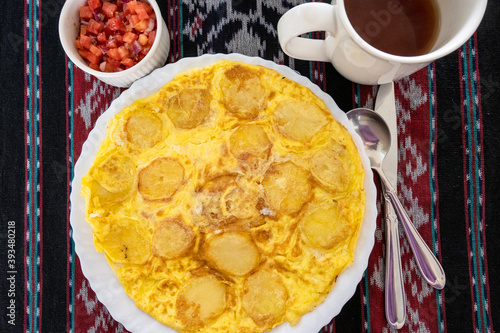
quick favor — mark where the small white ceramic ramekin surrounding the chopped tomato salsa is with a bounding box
[59,0,170,87]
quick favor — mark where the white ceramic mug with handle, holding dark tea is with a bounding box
[278,0,487,85]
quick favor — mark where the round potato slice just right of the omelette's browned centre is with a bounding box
[262,161,312,214]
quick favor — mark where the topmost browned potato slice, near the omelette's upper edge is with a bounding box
[220,65,267,119]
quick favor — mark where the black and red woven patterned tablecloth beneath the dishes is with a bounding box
[0,0,500,332]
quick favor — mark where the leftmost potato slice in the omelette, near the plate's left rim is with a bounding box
[92,153,136,193]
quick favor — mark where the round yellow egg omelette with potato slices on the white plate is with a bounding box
[82,60,365,333]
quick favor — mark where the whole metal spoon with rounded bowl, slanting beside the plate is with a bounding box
[347,109,446,289]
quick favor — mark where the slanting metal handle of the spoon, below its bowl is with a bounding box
[380,173,446,289]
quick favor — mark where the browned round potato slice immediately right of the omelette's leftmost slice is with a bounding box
[139,157,184,200]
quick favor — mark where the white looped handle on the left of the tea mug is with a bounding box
[278,2,337,61]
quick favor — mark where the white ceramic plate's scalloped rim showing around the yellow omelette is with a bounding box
[70,54,377,333]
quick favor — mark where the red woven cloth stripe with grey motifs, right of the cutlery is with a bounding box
[398,68,439,332]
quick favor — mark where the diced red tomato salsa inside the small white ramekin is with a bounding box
[75,0,157,72]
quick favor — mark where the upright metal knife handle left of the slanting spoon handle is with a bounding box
[384,190,406,329]
